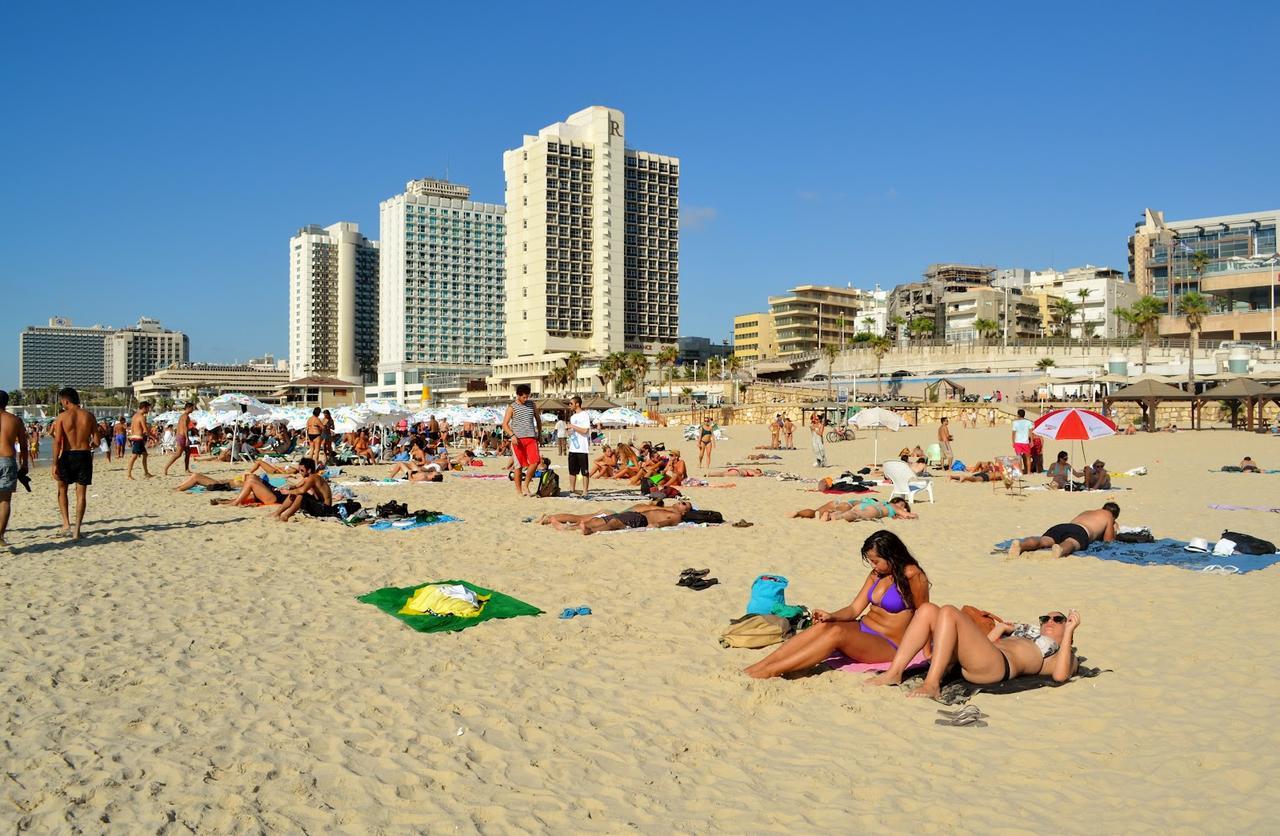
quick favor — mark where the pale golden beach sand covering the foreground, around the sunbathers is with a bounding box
[0,428,1280,833]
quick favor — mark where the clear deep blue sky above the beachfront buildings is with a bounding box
[0,3,1280,388]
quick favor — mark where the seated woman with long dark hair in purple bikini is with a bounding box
[746,529,929,679]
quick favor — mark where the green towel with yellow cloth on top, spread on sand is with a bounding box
[356,580,543,632]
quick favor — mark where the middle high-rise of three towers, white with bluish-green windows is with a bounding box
[366,179,507,403]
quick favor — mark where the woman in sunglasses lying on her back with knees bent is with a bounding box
[868,604,1080,696]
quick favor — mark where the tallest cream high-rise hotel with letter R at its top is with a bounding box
[490,106,680,390]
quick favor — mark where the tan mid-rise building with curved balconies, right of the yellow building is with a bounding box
[769,284,870,357]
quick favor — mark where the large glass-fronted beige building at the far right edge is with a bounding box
[1129,209,1280,341]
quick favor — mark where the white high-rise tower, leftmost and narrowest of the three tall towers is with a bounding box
[289,221,378,383]
